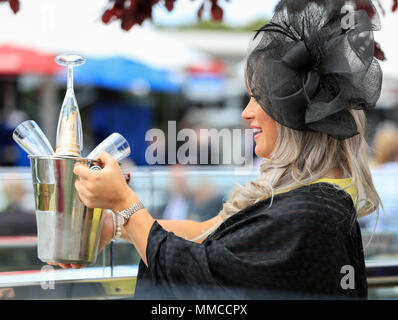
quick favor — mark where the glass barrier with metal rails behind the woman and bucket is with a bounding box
[0,167,398,299]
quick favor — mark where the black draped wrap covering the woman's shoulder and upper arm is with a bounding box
[135,182,367,299]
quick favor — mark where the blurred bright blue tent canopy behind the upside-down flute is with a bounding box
[65,57,180,93]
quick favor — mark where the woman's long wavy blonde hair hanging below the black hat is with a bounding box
[196,110,381,239]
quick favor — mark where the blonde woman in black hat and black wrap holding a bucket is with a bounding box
[53,0,381,299]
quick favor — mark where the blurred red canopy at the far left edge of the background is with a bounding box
[0,45,61,75]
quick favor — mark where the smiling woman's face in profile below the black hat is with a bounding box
[242,97,278,158]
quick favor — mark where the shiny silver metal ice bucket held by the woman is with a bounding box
[29,156,105,265]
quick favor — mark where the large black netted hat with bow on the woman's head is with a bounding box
[246,0,382,139]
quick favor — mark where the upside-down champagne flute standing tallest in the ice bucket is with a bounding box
[55,54,86,157]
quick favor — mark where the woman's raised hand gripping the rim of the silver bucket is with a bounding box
[73,152,137,212]
